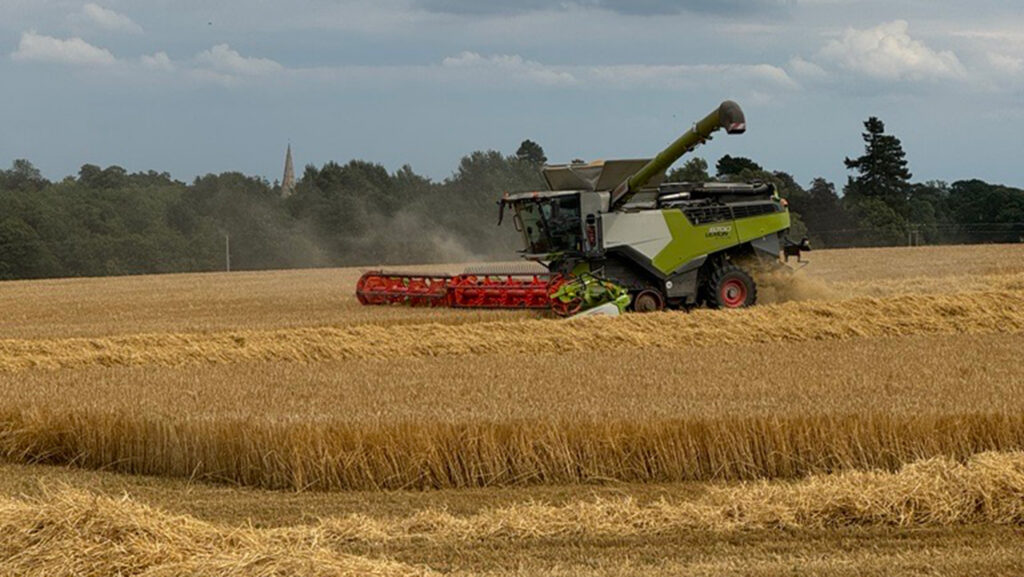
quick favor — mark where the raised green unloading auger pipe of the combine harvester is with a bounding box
[610,100,746,210]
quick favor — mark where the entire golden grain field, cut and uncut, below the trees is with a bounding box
[0,245,1024,576]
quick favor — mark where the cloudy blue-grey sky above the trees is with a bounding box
[0,0,1024,188]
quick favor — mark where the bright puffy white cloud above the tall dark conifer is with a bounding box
[818,20,966,80]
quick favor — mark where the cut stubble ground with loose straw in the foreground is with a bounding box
[6,454,1024,576]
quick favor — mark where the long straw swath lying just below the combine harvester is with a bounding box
[0,290,1024,371]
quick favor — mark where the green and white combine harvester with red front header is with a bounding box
[355,100,809,316]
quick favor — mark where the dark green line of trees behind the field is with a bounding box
[0,118,1024,279]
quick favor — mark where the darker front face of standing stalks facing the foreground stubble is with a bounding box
[0,409,1024,490]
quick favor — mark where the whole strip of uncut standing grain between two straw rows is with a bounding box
[0,334,1024,489]
